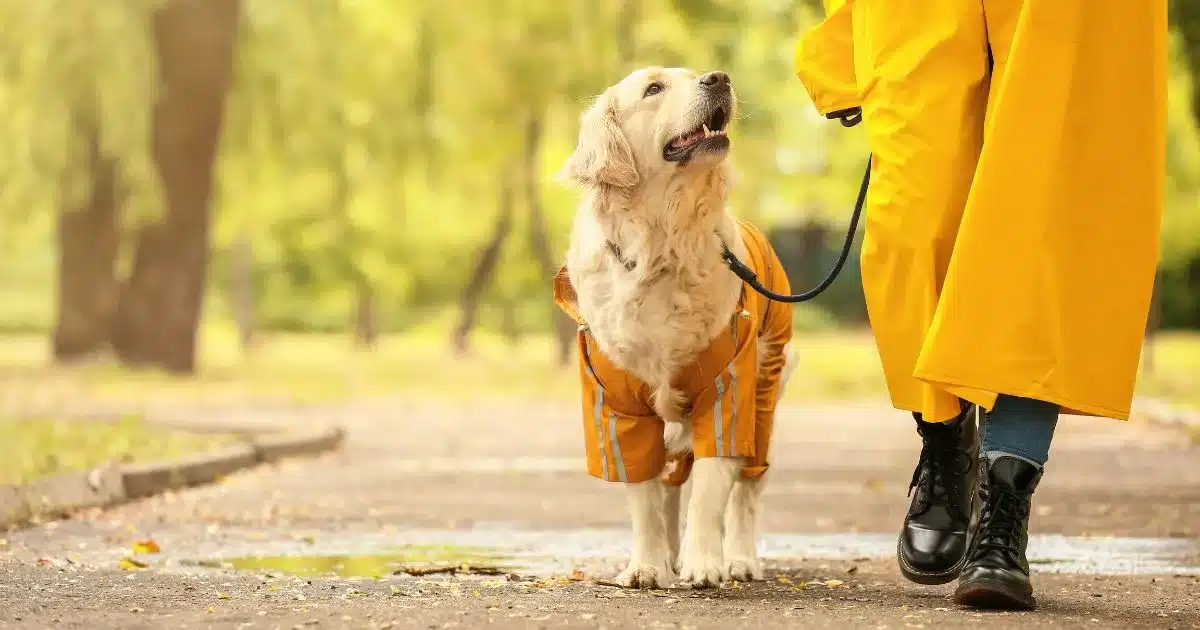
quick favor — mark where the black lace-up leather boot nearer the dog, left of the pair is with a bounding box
[896,404,979,584]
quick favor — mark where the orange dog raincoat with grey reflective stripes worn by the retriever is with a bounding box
[554,221,792,485]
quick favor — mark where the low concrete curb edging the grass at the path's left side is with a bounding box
[0,426,346,530]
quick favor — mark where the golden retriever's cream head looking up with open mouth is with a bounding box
[564,67,736,188]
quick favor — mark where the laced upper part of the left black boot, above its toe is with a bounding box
[908,420,972,521]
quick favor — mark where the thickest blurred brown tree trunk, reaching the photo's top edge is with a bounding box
[113,0,240,373]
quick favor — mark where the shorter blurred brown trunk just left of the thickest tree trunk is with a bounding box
[53,125,120,362]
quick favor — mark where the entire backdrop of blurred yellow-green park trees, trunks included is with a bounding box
[0,0,1200,373]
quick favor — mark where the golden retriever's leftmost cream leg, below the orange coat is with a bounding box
[617,479,676,588]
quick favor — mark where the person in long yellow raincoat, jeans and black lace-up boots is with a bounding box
[796,0,1168,608]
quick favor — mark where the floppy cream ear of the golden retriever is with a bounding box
[559,94,638,188]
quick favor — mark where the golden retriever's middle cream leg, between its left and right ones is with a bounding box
[679,457,744,588]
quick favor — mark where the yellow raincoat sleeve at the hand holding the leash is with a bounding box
[794,0,862,118]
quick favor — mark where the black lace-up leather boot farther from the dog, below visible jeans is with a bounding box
[954,455,1042,610]
